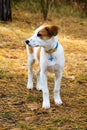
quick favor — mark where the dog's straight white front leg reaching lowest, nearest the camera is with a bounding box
[40,70,50,108]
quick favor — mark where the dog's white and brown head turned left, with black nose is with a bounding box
[26,25,58,47]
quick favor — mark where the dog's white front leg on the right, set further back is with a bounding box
[54,72,62,105]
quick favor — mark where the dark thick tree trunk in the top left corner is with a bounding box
[0,0,12,21]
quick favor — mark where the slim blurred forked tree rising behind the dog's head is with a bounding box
[40,0,54,20]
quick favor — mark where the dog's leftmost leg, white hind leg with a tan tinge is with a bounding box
[27,57,34,89]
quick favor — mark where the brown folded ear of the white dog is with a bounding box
[45,26,59,36]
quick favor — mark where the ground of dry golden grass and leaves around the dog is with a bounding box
[0,11,87,130]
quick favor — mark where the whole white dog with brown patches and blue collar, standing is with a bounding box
[26,25,65,108]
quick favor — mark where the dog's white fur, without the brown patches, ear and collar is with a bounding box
[26,26,65,108]
